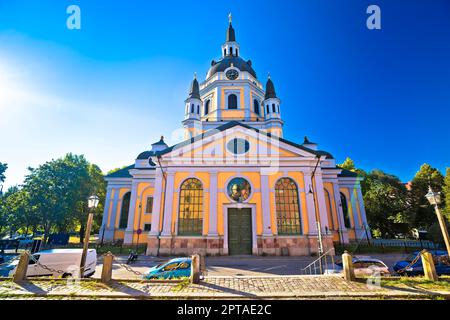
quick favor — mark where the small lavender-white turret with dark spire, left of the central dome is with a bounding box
[183,74,203,139]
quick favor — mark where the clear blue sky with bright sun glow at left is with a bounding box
[0,0,450,186]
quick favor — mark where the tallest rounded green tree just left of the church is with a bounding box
[24,153,105,240]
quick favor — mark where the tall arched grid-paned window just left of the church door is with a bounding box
[178,178,203,235]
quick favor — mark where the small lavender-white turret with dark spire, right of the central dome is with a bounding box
[263,74,283,137]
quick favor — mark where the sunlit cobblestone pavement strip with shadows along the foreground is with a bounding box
[0,276,446,299]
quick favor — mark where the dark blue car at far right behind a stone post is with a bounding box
[394,250,450,276]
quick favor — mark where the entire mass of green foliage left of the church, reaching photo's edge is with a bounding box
[0,153,106,239]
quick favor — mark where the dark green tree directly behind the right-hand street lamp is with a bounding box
[409,163,444,229]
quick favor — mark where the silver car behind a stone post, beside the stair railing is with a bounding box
[324,256,391,277]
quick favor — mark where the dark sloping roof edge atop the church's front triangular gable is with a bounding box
[155,121,334,159]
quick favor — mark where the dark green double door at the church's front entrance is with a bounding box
[228,209,252,255]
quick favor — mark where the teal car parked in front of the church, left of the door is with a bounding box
[143,258,191,279]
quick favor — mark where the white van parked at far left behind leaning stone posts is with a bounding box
[0,249,97,277]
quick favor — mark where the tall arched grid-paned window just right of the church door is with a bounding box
[275,178,302,235]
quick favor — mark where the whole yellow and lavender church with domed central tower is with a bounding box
[100,16,370,255]
